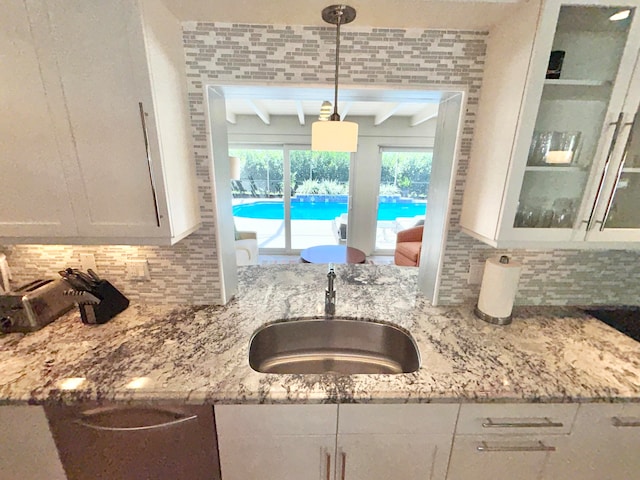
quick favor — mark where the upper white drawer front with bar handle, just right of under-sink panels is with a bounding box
[456,403,578,435]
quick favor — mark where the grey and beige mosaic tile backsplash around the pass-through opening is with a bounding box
[0,22,640,305]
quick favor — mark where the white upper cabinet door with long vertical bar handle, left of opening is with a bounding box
[46,0,169,238]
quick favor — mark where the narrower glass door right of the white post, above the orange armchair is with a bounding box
[375,147,433,253]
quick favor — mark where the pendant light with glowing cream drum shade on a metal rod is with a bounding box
[311,5,358,152]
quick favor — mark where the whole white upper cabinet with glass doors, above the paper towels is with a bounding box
[461,0,640,248]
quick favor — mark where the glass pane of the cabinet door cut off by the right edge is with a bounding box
[604,112,640,229]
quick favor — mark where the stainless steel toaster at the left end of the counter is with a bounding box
[0,279,75,333]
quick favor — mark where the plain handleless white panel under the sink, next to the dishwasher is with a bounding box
[214,405,338,437]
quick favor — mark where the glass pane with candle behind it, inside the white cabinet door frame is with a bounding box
[514,5,640,229]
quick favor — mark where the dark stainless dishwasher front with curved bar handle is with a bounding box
[45,405,220,480]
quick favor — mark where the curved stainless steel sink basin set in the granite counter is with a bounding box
[249,318,420,375]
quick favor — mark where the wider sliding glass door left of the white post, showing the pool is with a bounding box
[229,146,350,253]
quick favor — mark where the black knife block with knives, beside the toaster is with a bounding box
[59,268,129,325]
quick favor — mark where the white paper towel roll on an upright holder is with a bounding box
[478,256,522,319]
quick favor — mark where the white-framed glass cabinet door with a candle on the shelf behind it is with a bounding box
[500,1,639,242]
